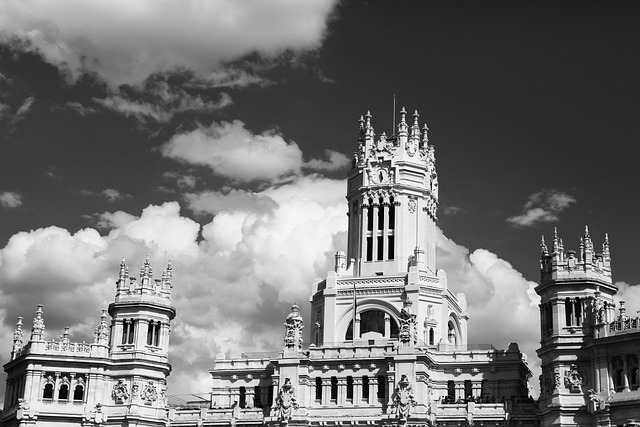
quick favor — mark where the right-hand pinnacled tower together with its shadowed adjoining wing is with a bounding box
[536,228,640,426]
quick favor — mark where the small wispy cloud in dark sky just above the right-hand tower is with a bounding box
[507,189,576,227]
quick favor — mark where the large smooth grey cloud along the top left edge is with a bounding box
[0,0,335,86]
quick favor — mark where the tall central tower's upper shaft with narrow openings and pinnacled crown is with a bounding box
[347,108,438,276]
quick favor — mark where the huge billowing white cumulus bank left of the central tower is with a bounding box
[0,176,346,393]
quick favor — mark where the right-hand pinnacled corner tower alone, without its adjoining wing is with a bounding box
[535,227,618,426]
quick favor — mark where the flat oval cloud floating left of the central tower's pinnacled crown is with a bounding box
[162,120,348,182]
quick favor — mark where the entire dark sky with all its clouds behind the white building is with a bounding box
[0,0,640,399]
